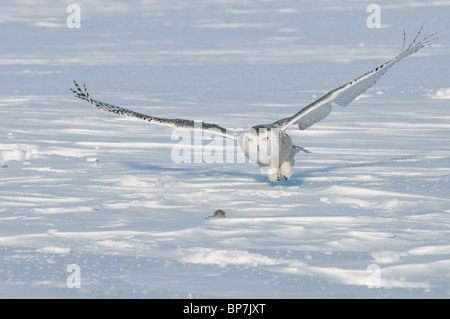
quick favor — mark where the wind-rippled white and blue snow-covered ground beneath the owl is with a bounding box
[0,0,450,298]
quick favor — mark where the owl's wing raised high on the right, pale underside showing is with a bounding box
[274,25,437,130]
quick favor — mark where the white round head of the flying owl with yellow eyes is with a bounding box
[238,125,281,166]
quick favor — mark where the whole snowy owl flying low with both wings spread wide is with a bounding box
[70,26,437,181]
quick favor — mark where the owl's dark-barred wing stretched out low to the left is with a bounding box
[70,81,237,139]
